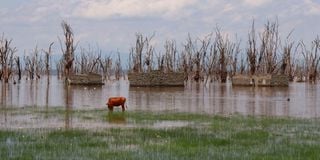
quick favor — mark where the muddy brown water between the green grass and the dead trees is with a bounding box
[0,76,320,118]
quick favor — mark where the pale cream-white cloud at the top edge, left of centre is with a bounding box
[74,0,196,19]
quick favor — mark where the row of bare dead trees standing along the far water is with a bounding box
[0,21,320,83]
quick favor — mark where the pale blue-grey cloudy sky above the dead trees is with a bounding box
[0,0,320,54]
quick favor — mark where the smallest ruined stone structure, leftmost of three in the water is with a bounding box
[66,73,104,85]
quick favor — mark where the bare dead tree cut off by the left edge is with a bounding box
[0,35,17,83]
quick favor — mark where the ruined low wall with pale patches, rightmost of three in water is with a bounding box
[232,74,289,87]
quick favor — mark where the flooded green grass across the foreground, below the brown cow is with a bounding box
[0,109,320,160]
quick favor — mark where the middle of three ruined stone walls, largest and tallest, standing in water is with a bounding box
[128,71,184,86]
